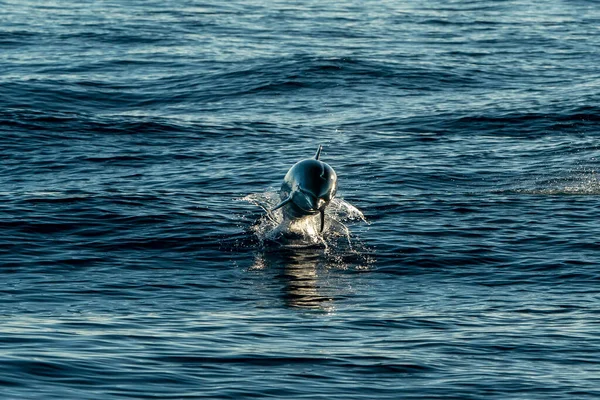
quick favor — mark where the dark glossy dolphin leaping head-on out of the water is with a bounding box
[271,145,337,232]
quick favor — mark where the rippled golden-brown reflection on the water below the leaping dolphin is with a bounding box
[251,248,334,311]
